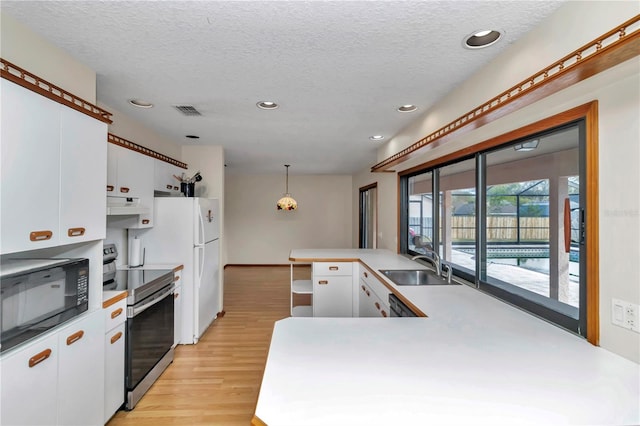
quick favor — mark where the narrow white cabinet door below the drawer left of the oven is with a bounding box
[103,322,126,423]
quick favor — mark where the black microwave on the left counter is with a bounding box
[0,259,89,352]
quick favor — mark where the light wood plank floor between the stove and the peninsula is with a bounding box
[108,266,310,426]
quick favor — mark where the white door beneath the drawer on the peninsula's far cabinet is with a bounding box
[313,276,353,317]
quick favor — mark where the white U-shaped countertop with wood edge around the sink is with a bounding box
[256,250,640,426]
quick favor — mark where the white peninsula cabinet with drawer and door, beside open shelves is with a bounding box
[312,262,353,317]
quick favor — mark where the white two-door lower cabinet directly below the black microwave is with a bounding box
[0,311,104,426]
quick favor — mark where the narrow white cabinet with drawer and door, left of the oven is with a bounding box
[103,299,127,423]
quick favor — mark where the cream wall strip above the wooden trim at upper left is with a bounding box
[0,13,96,104]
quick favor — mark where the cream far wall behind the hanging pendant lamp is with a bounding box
[225,170,352,264]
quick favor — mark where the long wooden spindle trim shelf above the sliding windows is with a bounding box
[371,15,640,172]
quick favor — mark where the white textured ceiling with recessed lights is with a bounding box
[0,0,561,174]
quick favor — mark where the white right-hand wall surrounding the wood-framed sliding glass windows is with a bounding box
[364,2,640,363]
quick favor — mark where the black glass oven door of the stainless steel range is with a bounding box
[125,285,174,391]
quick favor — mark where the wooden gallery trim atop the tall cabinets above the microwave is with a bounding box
[0,58,112,124]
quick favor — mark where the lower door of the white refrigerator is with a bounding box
[195,240,220,338]
